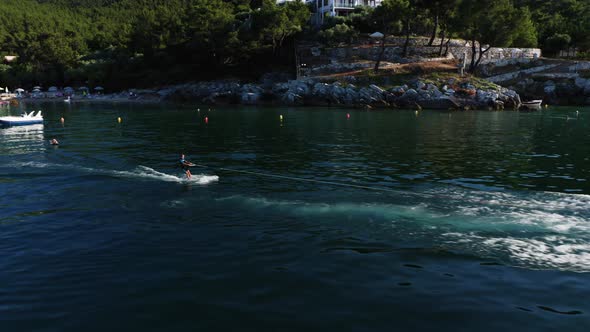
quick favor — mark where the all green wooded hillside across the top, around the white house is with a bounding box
[0,0,590,89]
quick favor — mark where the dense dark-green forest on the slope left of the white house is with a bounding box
[0,0,310,88]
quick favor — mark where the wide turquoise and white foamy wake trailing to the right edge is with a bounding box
[218,192,590,272]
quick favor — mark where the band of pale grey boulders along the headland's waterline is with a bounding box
[161,79,521,110]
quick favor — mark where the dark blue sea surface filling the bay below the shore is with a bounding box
[0,104,590,331]
